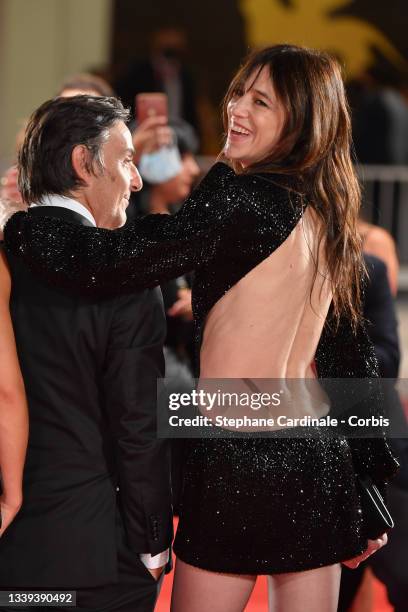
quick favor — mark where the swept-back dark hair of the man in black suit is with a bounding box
[18,96,129,204]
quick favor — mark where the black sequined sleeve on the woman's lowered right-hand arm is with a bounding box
[316,316,399,487]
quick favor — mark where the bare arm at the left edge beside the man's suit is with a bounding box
[0,252,28,536]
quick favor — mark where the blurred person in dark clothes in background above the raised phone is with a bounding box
[115,27,199,133]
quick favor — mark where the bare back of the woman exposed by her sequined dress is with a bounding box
[200,208,332,378]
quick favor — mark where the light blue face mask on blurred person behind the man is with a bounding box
[138,145,182,185]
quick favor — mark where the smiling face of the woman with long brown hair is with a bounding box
[224,66,285,167]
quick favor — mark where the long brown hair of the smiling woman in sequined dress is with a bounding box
[223,45,364,326]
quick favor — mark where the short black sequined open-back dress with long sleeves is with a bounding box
[5,163,397,574]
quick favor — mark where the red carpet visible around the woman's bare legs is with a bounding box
[155,521,393,612]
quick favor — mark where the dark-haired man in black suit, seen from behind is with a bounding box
[0,96,172,612]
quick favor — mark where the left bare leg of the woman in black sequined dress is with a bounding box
[171,559,256,612]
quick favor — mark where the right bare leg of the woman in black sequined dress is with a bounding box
[268,563,341,612]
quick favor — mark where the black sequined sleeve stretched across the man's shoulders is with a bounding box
[4,164,245,296]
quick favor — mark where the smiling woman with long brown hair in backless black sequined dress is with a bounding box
[6,45,396,612]
